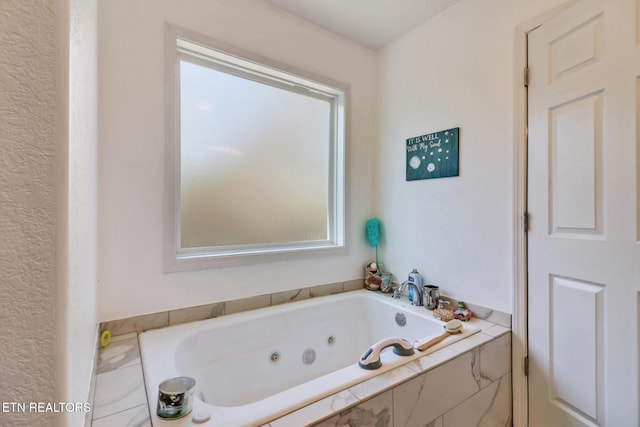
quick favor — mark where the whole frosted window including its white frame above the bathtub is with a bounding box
[166,27,346,270]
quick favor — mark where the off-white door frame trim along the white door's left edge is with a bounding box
[511,0,578,427]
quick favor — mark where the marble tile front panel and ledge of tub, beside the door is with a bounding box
[270,326,512,427]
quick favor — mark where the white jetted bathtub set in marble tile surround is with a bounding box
[140,290,478,427]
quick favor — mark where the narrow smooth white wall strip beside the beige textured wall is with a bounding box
[56,0,98,426]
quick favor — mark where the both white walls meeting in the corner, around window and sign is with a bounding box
[98,0,576,321]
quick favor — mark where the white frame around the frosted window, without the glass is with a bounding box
[164,23,348,271]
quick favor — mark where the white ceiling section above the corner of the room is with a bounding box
[265,0,459,50]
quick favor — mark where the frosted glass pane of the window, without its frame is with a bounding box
[180,61,331,248]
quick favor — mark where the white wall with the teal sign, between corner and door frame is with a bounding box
[375,0,563,312]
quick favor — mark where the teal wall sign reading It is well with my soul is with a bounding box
[407,128,460,181]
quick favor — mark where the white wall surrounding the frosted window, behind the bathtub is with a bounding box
[98,0,376,321]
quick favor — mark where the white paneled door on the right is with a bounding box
[528,0,640,427]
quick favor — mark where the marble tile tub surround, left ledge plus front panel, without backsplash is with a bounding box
[91,319,511,427]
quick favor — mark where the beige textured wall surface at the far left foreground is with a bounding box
[0,0,56,426]
